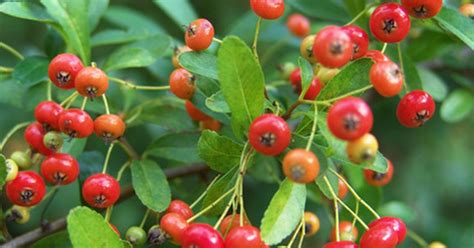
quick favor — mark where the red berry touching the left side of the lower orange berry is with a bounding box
[58,109,94,138]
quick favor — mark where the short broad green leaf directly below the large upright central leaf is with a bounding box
[198,130,243,173]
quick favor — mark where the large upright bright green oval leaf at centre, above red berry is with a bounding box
[217,36,265,138]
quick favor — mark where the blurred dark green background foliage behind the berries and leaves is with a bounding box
[0,0,474,247]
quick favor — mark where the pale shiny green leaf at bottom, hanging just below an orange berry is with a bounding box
[260,179,306,245]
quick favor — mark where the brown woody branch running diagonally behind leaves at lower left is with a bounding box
[0,164,209,248]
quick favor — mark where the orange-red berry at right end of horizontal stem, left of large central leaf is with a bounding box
[170,68,196,100]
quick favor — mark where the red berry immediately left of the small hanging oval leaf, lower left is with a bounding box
[82,173,120,208]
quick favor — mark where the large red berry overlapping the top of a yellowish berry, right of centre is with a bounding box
[327,97,374,141]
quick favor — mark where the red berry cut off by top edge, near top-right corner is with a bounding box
[402,0,443,19]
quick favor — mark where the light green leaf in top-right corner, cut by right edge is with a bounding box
[434,7,474,49]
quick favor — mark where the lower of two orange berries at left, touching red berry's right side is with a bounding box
[94,114,125,143]
